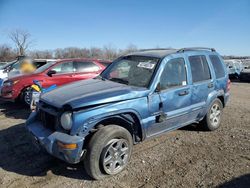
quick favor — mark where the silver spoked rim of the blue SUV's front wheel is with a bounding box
[102,139,130,174]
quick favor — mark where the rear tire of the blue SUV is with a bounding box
[201,98,223,131]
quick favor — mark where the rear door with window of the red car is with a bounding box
[73,61,102,80]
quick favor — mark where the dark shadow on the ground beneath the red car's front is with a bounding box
[0,101,30,119]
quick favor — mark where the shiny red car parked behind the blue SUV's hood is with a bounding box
[1,59,110,104]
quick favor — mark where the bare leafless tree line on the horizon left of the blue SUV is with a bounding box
[0,30,137,62]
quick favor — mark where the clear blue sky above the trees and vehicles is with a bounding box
[0,0,250,55]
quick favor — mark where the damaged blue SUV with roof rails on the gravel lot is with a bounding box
[26,48,230,179]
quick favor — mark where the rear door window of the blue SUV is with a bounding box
[188,55,211,82]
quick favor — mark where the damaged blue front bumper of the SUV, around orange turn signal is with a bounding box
[26,112,85,164]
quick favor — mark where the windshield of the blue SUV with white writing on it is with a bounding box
[101,56,159,87]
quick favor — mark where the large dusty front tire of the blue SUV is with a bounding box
[84,125,133,180]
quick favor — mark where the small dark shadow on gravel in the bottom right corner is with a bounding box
[219,174,250,188]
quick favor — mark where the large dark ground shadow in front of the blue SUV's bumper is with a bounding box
[0,124,91,180]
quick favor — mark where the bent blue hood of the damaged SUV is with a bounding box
[41,79,149,109]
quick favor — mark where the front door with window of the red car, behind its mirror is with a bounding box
[42,61,75,87]
